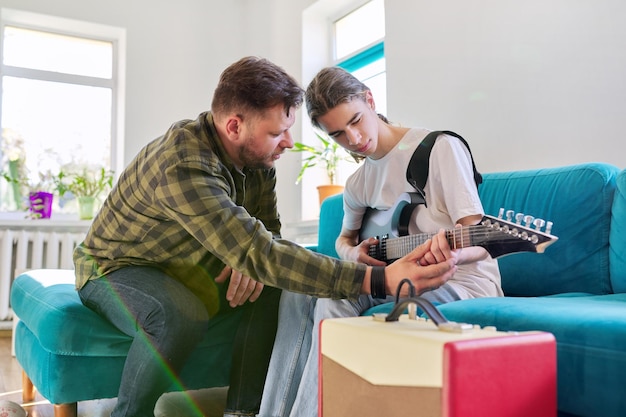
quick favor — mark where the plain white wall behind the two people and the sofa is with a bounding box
[0,0,626,231]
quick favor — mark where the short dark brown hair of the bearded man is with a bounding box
[211,56,304,117]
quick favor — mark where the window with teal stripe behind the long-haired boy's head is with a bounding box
[294,0,387,224]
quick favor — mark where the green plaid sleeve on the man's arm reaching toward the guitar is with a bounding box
[155,161,365,298]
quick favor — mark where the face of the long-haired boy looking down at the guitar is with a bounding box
[317,91,379,157]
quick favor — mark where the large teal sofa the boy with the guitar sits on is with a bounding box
[313,163,626,417]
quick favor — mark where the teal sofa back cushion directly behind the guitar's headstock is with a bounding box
[479,163,619,296]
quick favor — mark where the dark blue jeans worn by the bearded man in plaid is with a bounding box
[79,266,280,417]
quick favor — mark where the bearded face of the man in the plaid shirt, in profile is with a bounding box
[237,104,296,168]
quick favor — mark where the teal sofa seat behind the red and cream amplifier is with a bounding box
[438,294,626,417]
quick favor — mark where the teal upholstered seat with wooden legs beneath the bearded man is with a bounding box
[11,269,241,417]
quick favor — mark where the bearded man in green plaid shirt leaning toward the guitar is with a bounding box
[74,57,456,417]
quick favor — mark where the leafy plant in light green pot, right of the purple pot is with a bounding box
[56,167,113,220]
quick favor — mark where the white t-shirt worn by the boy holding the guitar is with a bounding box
[343,128,503,299]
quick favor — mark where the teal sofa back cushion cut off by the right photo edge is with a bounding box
[609,169,626,292]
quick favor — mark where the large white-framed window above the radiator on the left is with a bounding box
[0,9,124,211]
